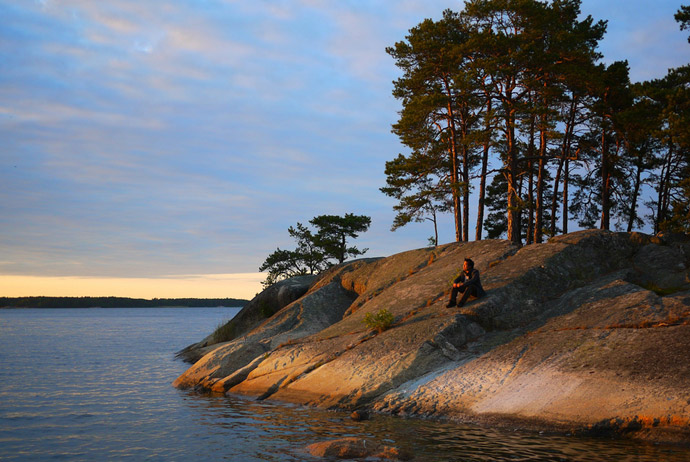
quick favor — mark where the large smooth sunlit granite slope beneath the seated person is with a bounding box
[175,230,690,441]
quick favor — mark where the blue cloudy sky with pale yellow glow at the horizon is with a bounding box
[0,0,690,299]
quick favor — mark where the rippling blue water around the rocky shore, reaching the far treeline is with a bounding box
[0,308,690,461]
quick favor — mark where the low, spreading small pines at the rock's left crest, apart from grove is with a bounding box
[259,213,371,287]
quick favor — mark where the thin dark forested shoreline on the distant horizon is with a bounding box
[0,297,249,308]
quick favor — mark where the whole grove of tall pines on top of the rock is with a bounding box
[381,0,690,244]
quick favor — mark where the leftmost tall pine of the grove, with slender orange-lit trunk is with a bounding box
[382,10,483,241]
